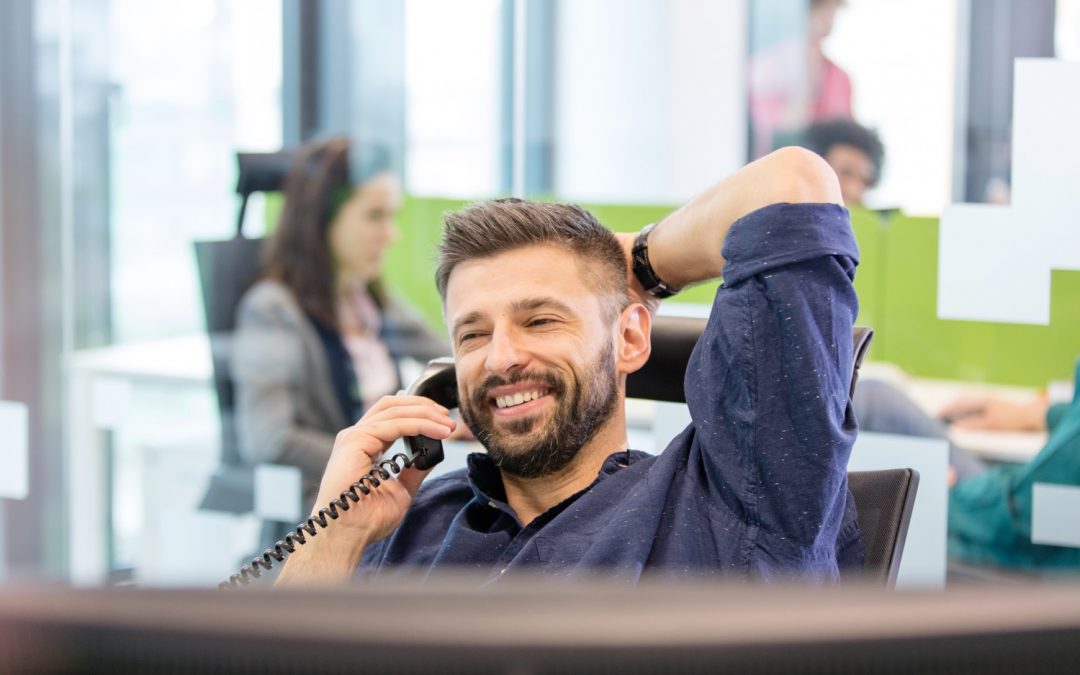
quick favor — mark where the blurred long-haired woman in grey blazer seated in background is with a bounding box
[232,137,450,550]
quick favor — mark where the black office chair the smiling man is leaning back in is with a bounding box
[626,316,919,588]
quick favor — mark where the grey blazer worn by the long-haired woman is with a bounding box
[230,281,450,503]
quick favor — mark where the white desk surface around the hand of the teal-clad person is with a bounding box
[860,361,1047,462]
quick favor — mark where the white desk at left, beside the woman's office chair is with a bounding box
[65,335,213,584]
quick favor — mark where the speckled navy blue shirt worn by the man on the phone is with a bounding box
[360,204,862,582]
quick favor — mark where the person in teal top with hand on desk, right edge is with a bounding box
[945,363,1080,571]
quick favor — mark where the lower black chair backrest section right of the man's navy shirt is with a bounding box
[843,469,919,588]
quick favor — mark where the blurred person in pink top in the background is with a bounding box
[750,0,852,159]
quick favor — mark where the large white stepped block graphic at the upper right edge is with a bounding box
[937,58,1080,325]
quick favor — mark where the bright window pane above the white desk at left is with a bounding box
[108,0,282,342]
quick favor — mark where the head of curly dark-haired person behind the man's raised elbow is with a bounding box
[800,119,885,206]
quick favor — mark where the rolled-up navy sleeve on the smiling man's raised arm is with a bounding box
[685,204,859,564]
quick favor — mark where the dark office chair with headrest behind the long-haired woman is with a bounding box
[194,152,293,514]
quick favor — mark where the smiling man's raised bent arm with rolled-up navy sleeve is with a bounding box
[635,148,859,579]
